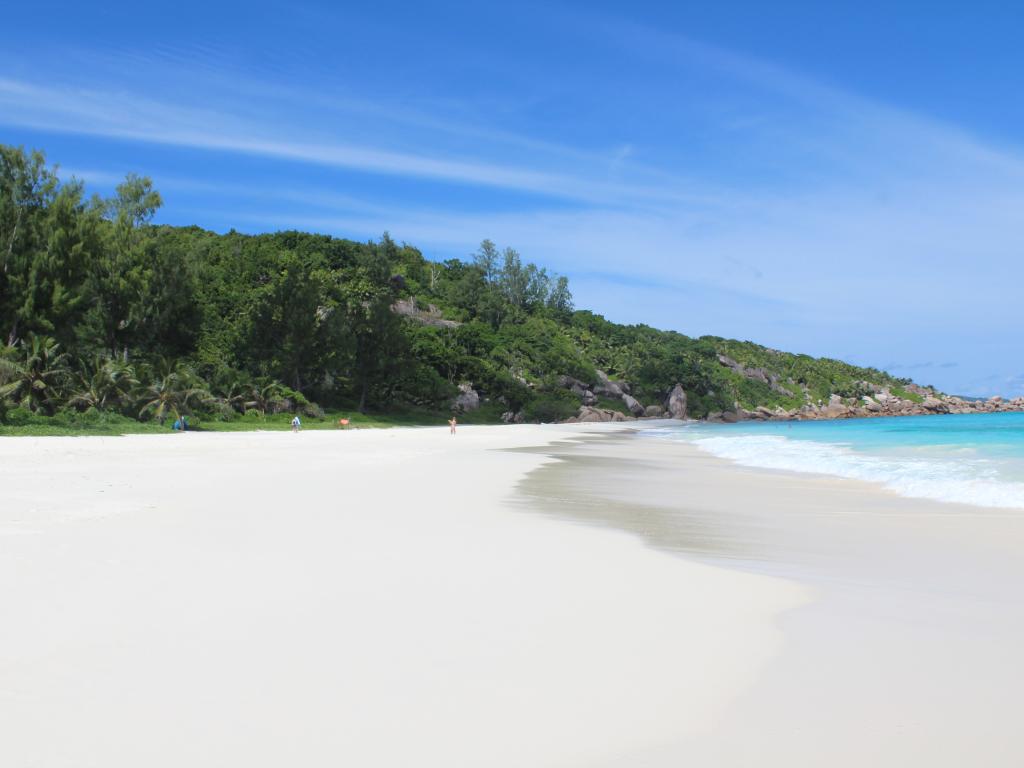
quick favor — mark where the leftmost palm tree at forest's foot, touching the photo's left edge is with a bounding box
[0,333,69,415]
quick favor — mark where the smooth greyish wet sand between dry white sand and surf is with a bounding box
[521,435,1024,767]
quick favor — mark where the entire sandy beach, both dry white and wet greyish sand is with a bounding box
[0,425,1024,768]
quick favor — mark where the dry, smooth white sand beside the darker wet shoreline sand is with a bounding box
[0,426,808,768]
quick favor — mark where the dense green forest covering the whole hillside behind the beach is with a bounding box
[0,145,913,434]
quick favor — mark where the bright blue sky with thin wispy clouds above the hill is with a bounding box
[0,1,1024,395]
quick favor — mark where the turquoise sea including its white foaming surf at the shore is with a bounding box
[649,413,1024,510]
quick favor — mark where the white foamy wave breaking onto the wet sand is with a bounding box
[687,435,1024,509]
